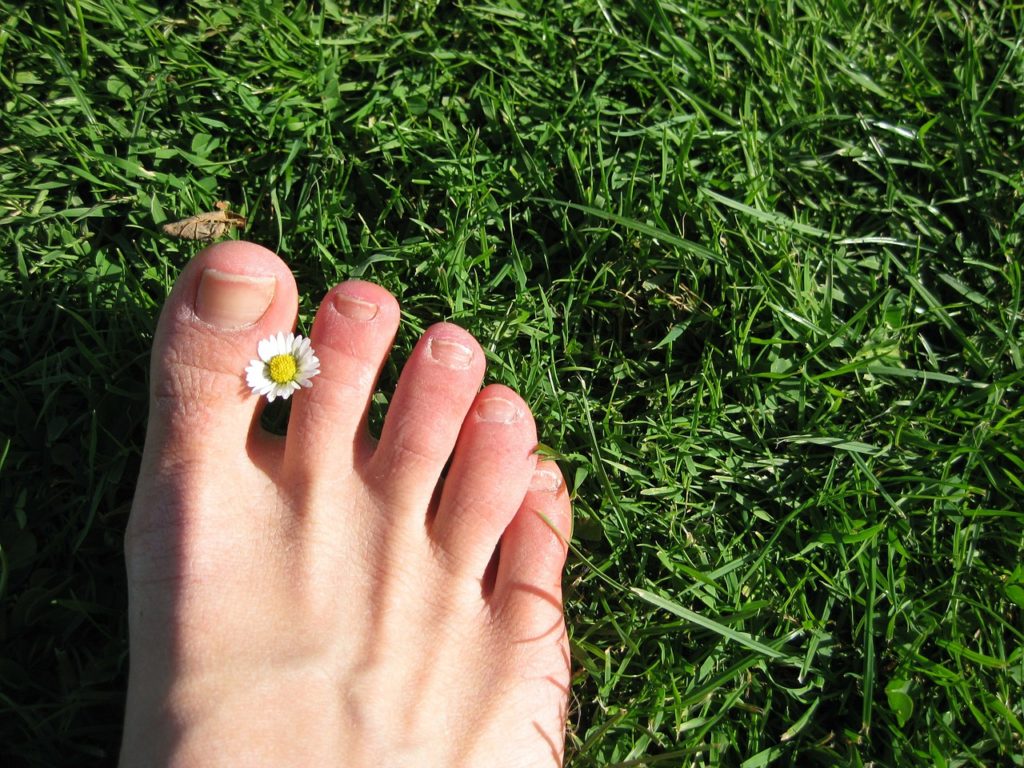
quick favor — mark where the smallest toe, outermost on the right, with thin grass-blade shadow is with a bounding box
[490,461,572,626]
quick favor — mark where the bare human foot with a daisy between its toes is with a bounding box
[121,242,570,767]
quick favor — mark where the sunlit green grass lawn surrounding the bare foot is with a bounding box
[0,0,1024,768]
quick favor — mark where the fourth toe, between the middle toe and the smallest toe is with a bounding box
[430,384,537,580]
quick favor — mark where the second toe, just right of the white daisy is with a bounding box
[285,281,399,477]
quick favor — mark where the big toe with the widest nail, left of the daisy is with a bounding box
[145,241,298,468]
